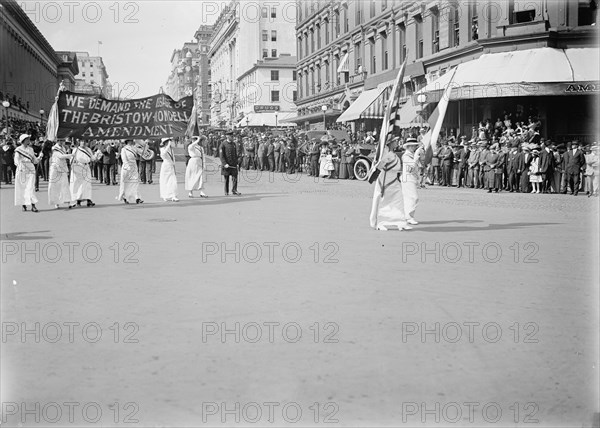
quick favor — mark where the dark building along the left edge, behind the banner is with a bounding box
[0,0,78,122]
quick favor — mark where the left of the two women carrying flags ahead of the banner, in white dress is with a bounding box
[370,137,412,230]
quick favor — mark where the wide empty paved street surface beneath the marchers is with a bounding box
[0,158,599,427]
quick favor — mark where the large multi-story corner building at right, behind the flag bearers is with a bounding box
[295,0,598,139]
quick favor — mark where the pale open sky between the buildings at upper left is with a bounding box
[17,0,228,98]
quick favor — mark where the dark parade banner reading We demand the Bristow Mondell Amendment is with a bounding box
[57,91,194,140]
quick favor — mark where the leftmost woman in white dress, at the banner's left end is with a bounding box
[14,134,43,213]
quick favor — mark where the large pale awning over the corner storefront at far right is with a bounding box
[418,48,600,101]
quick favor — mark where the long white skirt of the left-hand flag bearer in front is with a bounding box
[370,178,406,229]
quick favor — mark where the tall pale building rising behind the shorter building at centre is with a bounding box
[208,0,296,127]
